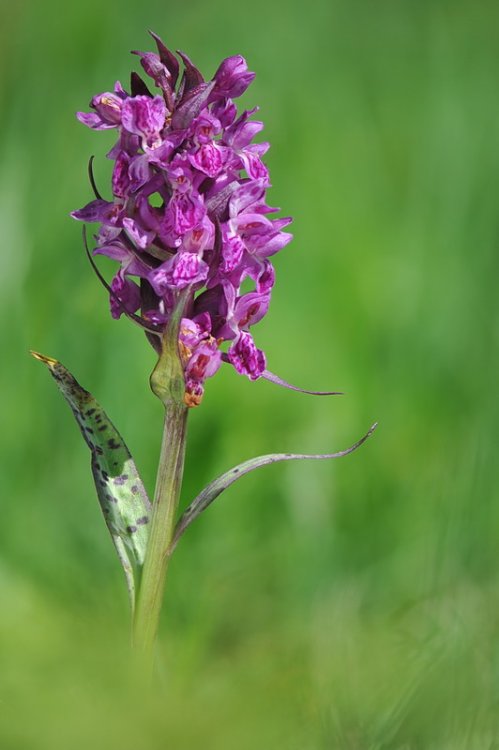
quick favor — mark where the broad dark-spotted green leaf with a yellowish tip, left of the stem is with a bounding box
[31,352,151,610]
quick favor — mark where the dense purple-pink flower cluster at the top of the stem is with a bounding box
[72,34,292,406]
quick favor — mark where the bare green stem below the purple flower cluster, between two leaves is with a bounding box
[133,403,187,672]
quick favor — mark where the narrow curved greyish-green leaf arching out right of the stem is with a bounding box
[170,422,378,551]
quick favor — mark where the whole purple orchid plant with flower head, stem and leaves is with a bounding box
[35,34,375,676]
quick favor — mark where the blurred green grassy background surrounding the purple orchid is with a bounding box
[0,0,499,750]
